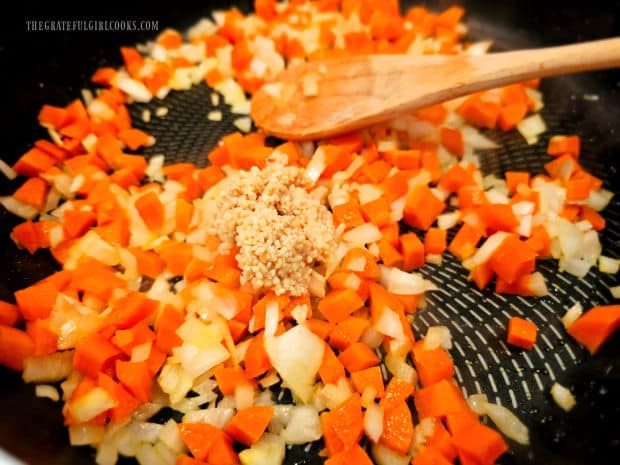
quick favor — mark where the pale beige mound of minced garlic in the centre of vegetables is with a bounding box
[213,155,335,295]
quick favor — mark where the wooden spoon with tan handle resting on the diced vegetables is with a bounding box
[252,38,620,140]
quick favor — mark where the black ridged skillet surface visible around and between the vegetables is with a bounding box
[0,0,620,465]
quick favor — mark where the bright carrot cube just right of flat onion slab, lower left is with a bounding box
[73,333,121,379]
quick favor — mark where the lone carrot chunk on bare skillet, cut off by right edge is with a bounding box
[567,305,620,354]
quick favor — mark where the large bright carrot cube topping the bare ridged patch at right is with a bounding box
[488,235,536,284]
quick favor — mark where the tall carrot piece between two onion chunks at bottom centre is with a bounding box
[321,394,363,456]
